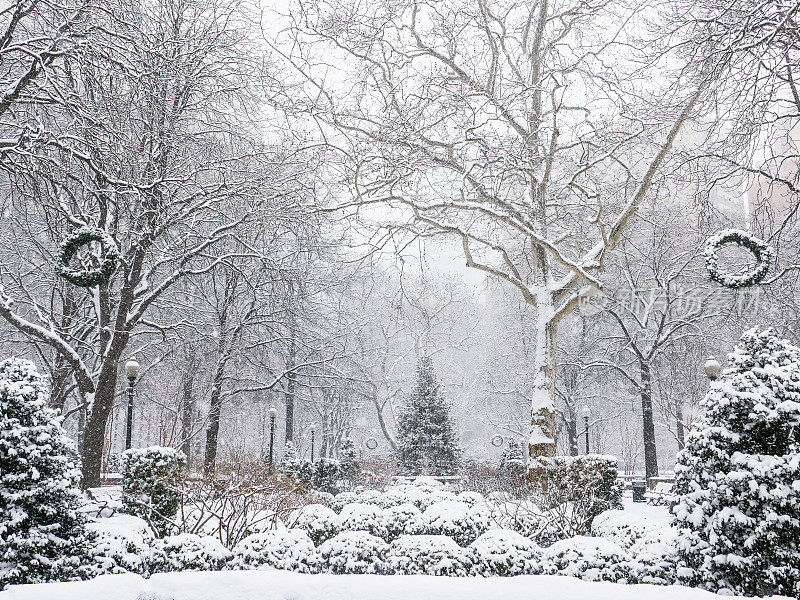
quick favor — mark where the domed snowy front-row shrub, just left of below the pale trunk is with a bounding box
[469,529,541,577]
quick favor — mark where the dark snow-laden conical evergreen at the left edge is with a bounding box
[0,358,91,589]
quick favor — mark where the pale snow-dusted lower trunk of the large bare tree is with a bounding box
[528,314,557,457]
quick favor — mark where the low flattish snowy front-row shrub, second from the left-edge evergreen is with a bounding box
[150,533,232,573]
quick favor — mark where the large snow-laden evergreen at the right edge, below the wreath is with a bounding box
[673,329,800,597]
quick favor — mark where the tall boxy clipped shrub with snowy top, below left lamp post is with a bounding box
[122,446,186,535]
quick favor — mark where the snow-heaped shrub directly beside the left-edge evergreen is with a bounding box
[86,515,164,577]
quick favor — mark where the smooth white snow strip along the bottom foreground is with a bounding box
[0,571,760,600]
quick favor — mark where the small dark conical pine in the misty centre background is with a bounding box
[397,357,461,475]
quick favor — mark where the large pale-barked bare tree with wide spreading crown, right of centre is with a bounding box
[275,0,703,454]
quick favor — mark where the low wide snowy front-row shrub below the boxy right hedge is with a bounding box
[542,535,628,581]
